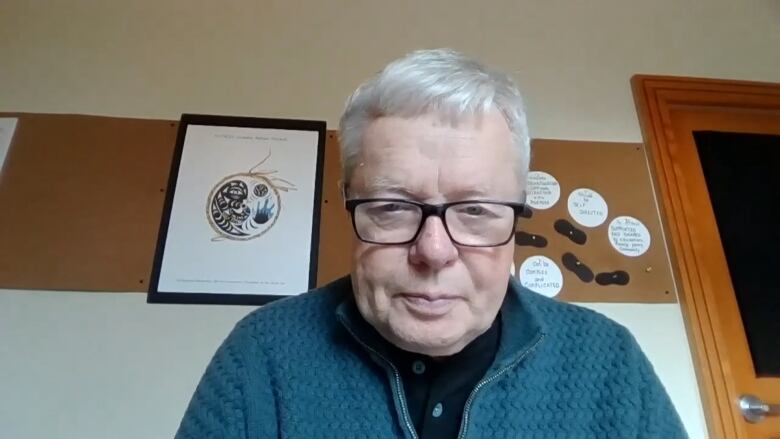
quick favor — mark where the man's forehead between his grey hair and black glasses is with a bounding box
[352,116,522,199]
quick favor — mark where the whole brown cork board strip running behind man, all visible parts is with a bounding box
[0,113,676,303]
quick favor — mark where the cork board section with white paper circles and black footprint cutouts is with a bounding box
[514,139,677,303]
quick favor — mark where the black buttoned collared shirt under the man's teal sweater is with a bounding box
[384,315,501,439]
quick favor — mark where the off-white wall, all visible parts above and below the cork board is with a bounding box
[0,0,780,439]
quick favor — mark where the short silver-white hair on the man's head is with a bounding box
[339,49,531,189]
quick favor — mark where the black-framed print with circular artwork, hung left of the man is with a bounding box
[147,114,325,305]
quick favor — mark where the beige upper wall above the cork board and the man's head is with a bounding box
[0,0,780,141]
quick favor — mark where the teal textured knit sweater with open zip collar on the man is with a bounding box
[176,277,686,439]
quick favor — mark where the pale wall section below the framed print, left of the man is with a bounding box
[0,290,253,439]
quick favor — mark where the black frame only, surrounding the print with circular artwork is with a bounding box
[147,114,326,305]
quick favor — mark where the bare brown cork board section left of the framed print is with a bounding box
[0,113,178,291]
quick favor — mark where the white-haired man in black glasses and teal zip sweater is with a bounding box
[177,50,685,438]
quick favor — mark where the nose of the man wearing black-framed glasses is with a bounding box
[409,216,458,270]
